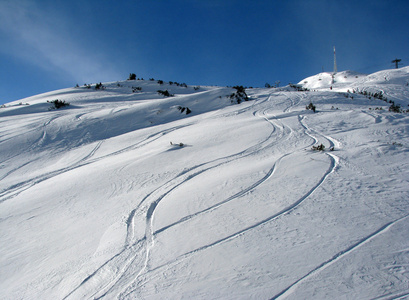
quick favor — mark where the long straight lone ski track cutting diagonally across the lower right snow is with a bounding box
[271,215,409,299]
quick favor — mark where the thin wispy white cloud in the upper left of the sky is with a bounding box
[0,1,119,82]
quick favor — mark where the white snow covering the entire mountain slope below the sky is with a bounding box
[0,67,409,299]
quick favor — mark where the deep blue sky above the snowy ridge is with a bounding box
[0,0,409,103]
